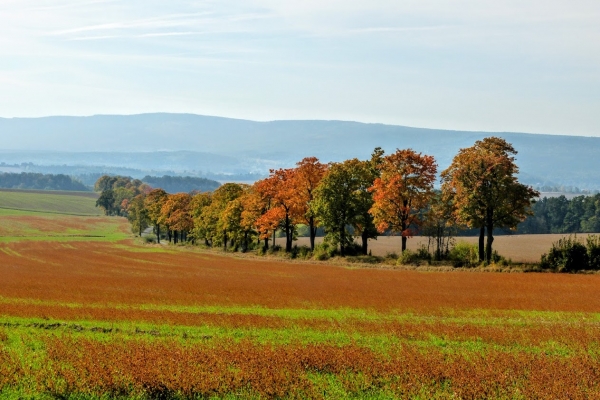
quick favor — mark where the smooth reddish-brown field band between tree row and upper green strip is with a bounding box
[0,242,600,312]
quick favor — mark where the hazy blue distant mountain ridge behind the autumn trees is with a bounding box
[0,113,600,189]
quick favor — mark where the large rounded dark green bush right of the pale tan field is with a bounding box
[540,236,595,272]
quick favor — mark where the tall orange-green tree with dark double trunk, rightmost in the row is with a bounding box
[442,137,539,263]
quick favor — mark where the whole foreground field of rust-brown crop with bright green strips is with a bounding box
[0,192,600,399]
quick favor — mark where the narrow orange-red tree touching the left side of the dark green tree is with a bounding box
[293,157,327,251]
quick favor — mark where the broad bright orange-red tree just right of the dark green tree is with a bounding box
[370,149,437,252]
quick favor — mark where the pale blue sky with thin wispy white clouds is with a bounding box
[0,0,600,136]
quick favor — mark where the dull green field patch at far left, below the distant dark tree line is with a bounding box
[0,191,102,215]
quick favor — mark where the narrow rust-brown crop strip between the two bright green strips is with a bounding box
[0,304,600,353]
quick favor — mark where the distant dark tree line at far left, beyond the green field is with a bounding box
[0,172,90,191]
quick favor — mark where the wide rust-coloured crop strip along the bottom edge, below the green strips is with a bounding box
[0,336,600,399]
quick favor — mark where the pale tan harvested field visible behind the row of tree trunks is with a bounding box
[292,234,588,263]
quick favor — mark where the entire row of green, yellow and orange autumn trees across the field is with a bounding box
[96,137,539,262]
